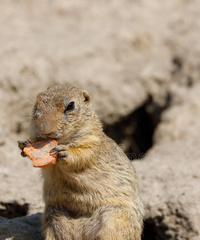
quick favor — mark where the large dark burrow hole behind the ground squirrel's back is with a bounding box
[104,94,171,160]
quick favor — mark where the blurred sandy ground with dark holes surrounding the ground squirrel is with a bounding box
[0,0,200,240]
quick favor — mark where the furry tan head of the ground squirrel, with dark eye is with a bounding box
[32,85,99,141]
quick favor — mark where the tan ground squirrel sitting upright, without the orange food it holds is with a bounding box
[20,84,143,240]
